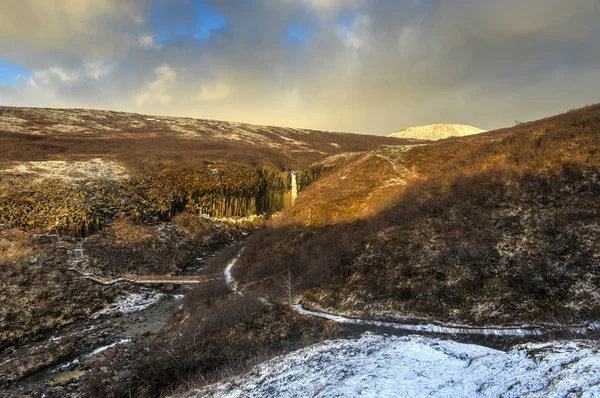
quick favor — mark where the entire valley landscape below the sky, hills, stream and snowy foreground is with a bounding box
[0,105,600,397]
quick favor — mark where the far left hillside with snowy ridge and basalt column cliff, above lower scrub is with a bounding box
[0,107,410,236]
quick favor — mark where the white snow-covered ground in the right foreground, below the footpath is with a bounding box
[187,334,600,398]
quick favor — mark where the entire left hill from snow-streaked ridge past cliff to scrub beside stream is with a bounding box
[0,107,410,388]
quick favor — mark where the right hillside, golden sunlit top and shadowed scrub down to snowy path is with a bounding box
[236,105,600,324]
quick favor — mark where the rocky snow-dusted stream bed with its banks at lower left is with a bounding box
[0,241,236,397]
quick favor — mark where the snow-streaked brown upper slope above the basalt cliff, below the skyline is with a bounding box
[0,107,409,169]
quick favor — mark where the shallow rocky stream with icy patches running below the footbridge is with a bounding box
[0,248,229,396]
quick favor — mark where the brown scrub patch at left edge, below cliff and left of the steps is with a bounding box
[0,229,110,351]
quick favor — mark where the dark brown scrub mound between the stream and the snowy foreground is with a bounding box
[82,282,337,397]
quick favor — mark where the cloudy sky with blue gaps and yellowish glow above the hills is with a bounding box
[0,0,600,135]
